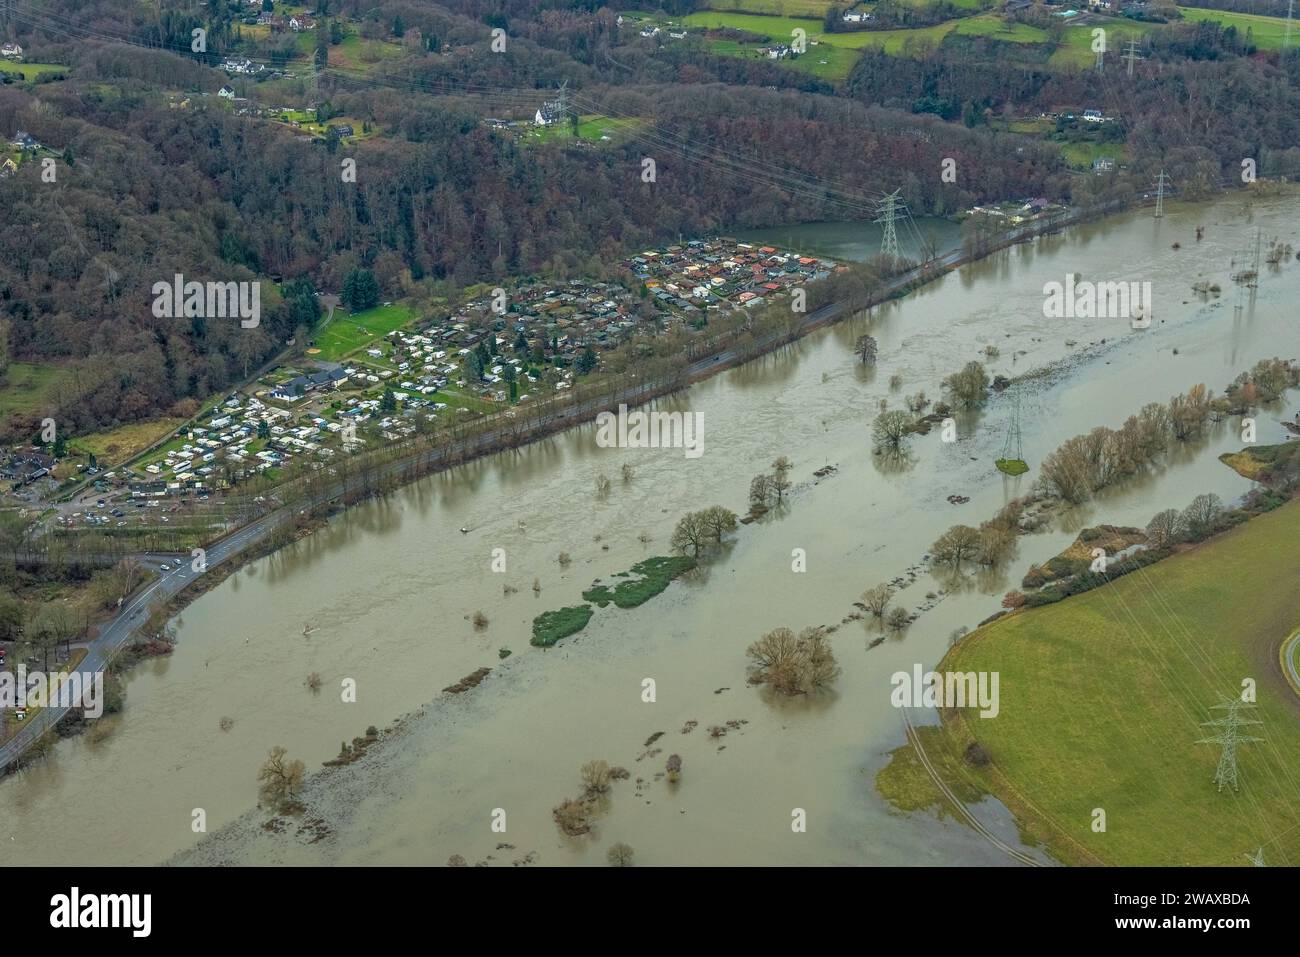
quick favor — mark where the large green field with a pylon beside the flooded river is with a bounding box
[930,502,1300,866]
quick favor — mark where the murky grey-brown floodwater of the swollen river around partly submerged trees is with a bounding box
[0,191,1300,865]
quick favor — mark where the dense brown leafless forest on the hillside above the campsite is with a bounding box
[0,0,1300,434]
